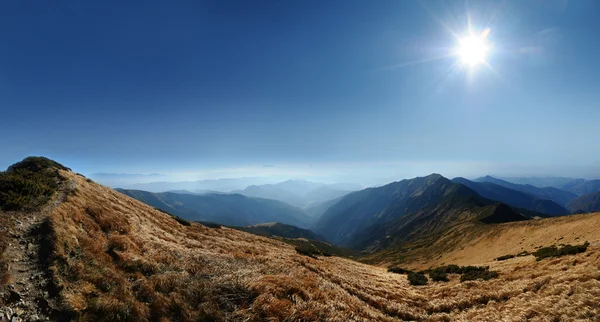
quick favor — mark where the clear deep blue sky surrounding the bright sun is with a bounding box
[0,0,600,182]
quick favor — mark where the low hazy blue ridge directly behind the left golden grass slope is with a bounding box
[117,189,311,228]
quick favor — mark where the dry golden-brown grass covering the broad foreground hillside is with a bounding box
[49,172,600,321]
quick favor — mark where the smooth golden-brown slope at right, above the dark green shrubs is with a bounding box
[366,213,600,267]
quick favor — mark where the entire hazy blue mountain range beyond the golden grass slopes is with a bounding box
[119,174,600,253]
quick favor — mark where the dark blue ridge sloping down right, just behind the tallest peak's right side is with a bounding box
[452,178,570,216]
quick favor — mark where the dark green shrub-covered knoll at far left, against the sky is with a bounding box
[0,157,67,211]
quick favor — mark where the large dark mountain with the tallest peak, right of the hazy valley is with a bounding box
[315,174,525,251]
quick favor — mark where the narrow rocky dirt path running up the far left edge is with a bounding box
[0,183,72,322]
